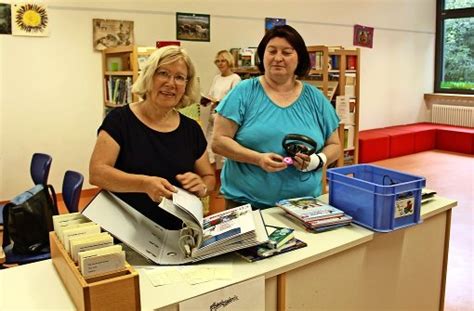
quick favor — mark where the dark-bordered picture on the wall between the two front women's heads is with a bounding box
[176,12,211,42]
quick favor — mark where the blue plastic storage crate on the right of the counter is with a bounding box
[327,164,426,232]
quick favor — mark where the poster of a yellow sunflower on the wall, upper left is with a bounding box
[11,3,49,37]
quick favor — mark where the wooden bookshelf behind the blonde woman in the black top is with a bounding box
[102,45,155,114]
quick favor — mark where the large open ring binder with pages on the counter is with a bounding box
[82,188,268,265]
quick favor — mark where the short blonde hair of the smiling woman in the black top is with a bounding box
[132,45,200,109]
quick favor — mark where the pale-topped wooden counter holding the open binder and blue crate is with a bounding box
[0,197,456,310]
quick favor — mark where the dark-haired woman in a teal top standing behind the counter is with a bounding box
[212,25,340,208]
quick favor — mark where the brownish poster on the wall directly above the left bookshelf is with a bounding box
[92,18,135,51]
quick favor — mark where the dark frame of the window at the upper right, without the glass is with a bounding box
[434,0,474,94]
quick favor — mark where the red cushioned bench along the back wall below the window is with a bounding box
[359,123,474,163]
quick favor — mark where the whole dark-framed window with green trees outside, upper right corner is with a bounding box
[434,0,474,94]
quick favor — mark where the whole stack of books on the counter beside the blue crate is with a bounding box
[276,197,352,232]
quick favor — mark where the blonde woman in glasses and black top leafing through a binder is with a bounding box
[89,46,215,228]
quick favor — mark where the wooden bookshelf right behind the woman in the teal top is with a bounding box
[304,45,360,166]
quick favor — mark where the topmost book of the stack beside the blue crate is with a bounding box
[276,197,344,222]
